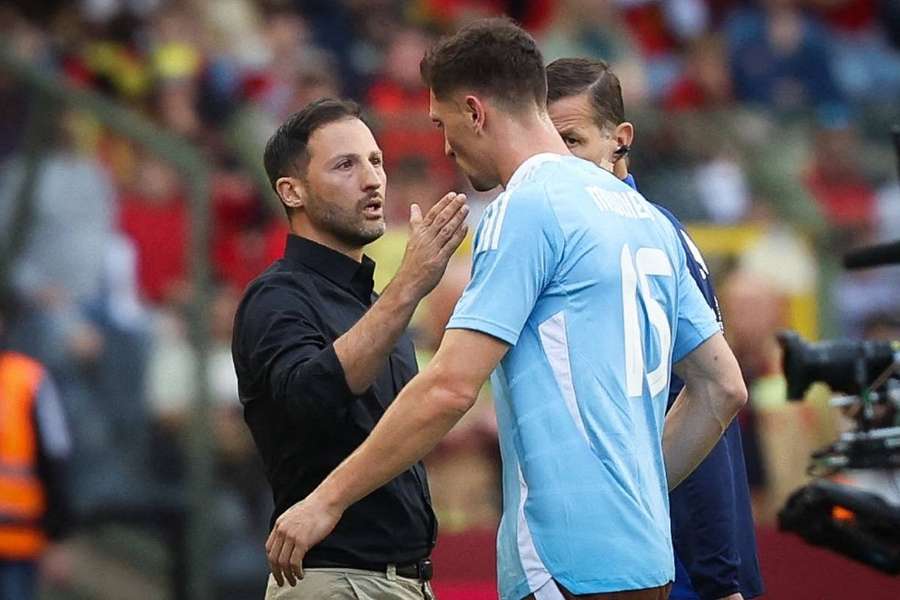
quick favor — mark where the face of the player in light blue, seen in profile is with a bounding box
[428,92,500,192]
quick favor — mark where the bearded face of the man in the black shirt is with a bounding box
[300,118,387,248]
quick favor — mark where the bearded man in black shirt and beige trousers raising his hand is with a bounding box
[232,100,468,599]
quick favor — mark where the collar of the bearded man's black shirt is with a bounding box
[284,234,375,302]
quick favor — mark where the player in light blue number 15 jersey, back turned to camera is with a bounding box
[267,19,746,600]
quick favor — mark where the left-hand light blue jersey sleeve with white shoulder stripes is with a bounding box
[447,186,564,345]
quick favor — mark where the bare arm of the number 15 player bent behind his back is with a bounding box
[663,333,747,490]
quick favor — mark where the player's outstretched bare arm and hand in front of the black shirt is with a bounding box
[266,329,509,586]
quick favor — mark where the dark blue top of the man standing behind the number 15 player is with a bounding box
[625,175,763,600]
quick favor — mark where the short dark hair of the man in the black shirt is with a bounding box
[263,98,360,218]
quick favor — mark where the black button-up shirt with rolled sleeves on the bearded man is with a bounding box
[232,235,437,568]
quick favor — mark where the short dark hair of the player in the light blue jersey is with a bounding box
[419,17,547,108]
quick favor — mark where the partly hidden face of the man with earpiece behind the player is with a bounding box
[547,93,631,168]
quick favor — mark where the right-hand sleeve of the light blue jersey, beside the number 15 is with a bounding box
[672,244,721,363]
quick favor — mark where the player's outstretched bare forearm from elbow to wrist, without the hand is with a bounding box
[314,370,478,512]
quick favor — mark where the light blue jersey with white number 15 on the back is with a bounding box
[448,154,719,600]
